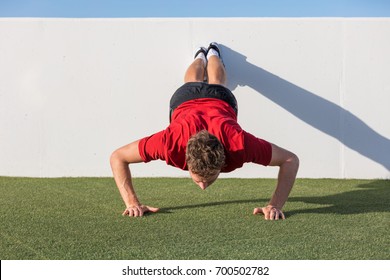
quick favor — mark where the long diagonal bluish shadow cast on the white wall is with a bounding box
[221,45,390,170]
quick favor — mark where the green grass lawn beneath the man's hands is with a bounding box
[0,177,390,260]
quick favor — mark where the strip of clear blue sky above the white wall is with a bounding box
[0,0,390,18]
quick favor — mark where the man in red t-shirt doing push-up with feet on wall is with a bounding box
[110,43,299,220]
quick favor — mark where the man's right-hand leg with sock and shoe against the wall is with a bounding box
[207,43,226,86]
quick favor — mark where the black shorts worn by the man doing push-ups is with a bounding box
[169,82,238,121]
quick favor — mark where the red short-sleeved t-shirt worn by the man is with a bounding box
[138,98,272,172]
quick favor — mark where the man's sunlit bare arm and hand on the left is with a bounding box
[110,140,159,217]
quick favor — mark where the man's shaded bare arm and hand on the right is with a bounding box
[253,144,299,220]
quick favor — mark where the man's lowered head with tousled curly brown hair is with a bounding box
[186,130,225,189]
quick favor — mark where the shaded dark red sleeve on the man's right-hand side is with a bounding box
[244,132,272,166]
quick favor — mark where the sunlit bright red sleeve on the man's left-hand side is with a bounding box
[138,130,165,162]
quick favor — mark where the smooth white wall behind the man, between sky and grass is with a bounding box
[0,18,390,178]
